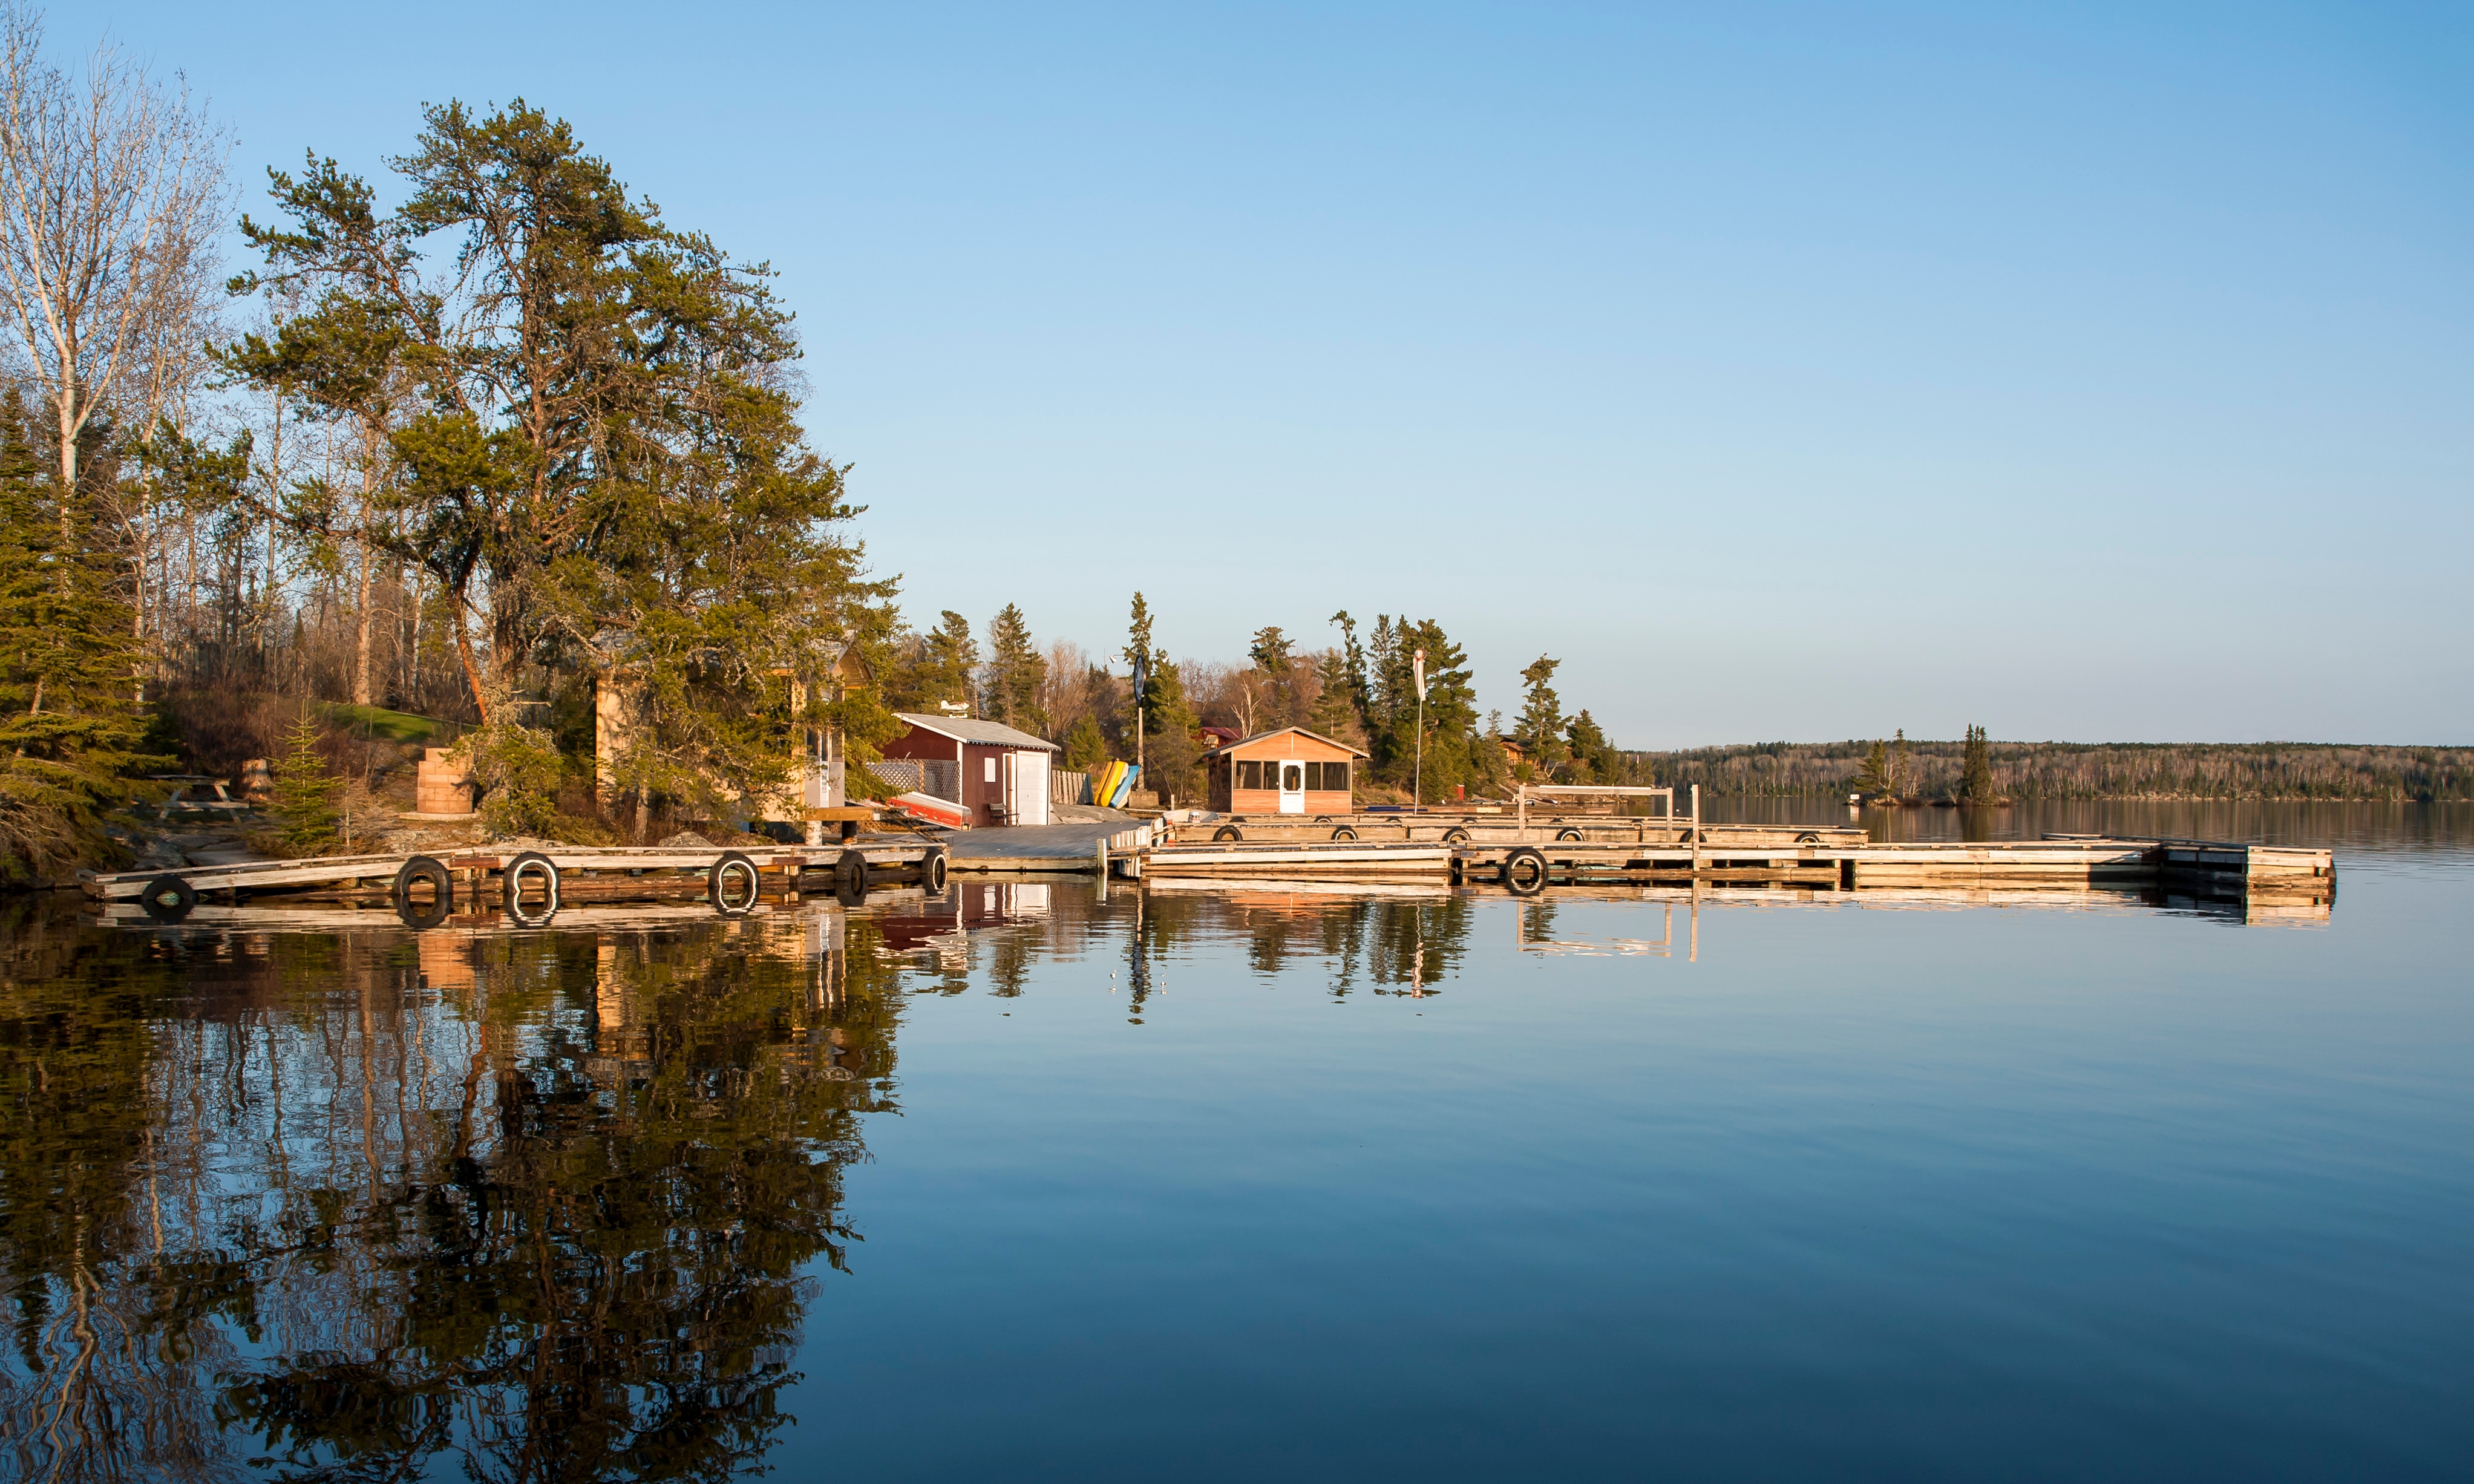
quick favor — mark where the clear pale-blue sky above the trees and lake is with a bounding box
[67,5,2474,747]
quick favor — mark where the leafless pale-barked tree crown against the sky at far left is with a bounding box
[0,0,230,520]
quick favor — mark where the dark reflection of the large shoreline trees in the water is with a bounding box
[0,905,895,1479]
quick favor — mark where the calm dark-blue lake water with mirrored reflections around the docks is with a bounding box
[0,806,2474,1479]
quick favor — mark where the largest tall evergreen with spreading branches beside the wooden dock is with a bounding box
[220,99,898,811]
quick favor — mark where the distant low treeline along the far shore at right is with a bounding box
[1623,739,2474,802]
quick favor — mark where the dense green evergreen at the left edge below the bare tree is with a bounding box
[0,391,166,883]
